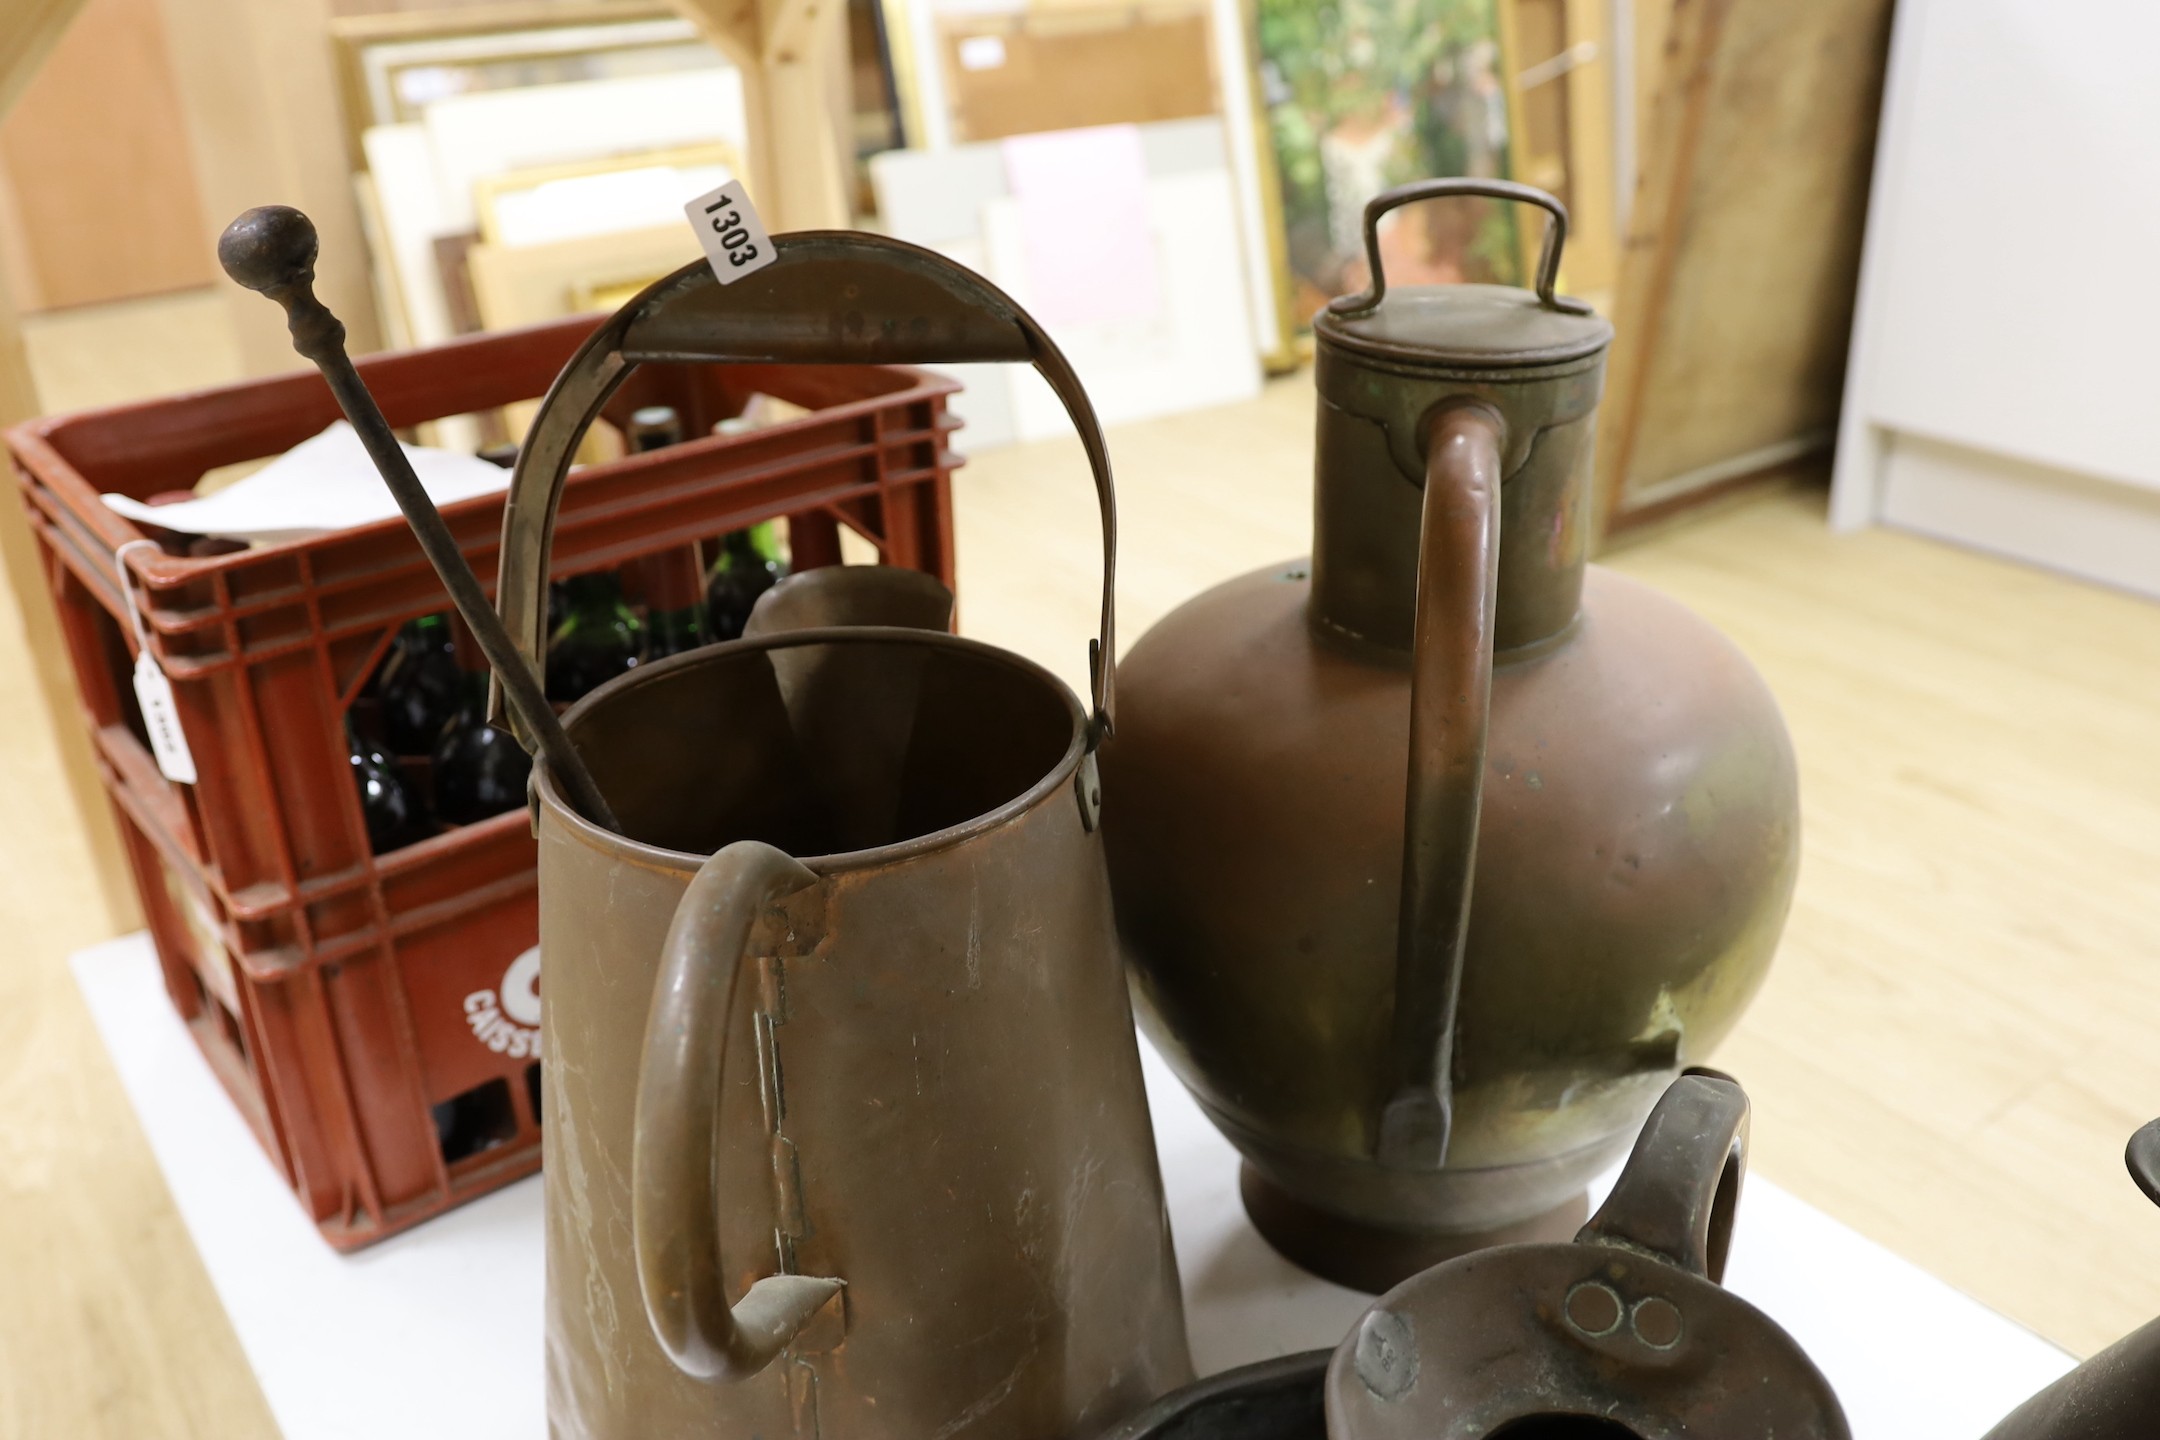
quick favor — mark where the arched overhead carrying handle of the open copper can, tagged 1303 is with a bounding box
[490,231,1117,764]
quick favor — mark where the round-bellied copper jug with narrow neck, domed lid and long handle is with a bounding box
[1104,179,1799,1291]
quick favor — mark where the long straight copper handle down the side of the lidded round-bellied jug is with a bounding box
[1378,402,1503,1170]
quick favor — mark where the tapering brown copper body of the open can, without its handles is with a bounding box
[540,630,1188,1440]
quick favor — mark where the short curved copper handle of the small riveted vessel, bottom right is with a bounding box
[1575,1067,1747,1280]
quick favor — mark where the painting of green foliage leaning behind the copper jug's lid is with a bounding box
[1253,0,1523,330]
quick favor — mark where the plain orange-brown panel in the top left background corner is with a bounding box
[0,0,214,309]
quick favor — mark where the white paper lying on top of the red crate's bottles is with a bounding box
[104,421,510,544]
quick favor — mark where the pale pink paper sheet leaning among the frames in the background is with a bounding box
[1004,125,1162,326]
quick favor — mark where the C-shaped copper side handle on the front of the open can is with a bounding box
[631,840,845,1382]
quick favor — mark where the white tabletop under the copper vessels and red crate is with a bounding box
[73,935,2069,1440]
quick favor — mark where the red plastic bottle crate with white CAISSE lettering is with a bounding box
[6,317,957,1250]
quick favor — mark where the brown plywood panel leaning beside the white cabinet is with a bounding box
[1598,0,1890,529]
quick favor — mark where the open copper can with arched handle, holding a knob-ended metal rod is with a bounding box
[220,212,1190,1440]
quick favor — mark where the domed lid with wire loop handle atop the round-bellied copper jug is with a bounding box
[1313,179,1614,369]
